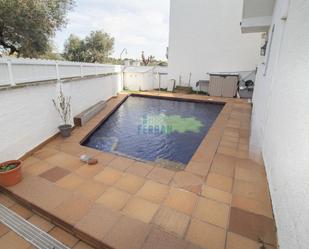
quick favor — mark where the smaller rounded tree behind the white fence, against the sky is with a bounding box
[63,31,114,63]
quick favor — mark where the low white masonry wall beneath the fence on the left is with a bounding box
[0,74,121,161]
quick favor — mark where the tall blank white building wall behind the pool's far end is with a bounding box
[168,0,261,86]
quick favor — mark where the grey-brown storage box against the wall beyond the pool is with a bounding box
[208,73,239,98]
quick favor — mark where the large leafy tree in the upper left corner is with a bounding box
[0,0,74,57]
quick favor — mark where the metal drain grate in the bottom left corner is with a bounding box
[0,204,69,249]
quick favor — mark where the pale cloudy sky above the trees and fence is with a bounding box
[54,0,169,60]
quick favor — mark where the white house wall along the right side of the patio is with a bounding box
[251,0,309,249]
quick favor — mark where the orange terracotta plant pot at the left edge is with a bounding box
[0,160,22,187]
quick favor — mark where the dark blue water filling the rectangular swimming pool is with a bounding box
[83,96,223,165]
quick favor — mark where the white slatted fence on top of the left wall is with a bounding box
[0,58,122,86]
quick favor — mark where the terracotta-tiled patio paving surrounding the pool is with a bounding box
[0,93,276,249]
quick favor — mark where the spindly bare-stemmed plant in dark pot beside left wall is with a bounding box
[53,85,72,137]
